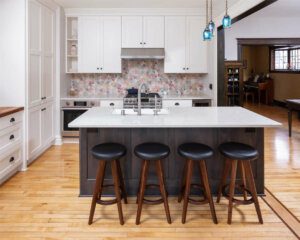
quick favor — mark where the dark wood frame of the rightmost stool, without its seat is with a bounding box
[217,158,263,224]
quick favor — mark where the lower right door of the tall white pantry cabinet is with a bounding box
[41,102,54,144]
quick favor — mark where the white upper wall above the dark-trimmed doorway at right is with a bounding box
[225,0,300,60]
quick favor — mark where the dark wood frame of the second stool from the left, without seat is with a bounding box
[135,159,171,225]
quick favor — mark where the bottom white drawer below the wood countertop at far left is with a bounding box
[0,145,22,177]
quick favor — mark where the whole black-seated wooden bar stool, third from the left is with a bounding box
[178,143,218,224]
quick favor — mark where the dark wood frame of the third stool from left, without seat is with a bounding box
[178,159,218,224]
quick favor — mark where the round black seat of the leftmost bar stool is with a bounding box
[91,143,126,161]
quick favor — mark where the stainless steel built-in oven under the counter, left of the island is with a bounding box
[61,100,100,137]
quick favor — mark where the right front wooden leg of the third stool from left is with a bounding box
[199,160,218,224]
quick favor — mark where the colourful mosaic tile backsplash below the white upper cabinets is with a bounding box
[71,60,208,97]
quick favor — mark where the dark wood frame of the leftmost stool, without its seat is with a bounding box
[89,159,127,225]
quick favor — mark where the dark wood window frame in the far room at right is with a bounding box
[269,47,300,74]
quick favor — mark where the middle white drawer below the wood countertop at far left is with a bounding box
[0,123,22,152]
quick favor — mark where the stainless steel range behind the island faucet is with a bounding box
[123,93,162,109]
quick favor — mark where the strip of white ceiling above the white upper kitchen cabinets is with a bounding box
[55,0,239,15]
